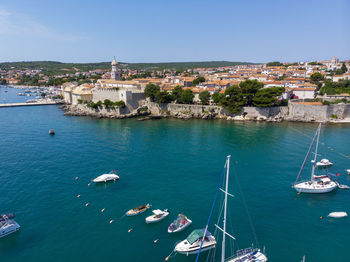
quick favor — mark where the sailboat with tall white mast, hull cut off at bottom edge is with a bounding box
[196,155,267,262]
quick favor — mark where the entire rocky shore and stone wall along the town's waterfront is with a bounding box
[62,102,350,123]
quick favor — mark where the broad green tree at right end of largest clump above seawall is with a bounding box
[253,87,285,107]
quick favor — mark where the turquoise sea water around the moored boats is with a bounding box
[0,87,350,262]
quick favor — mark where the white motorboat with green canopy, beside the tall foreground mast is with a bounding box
[174,229,216,255]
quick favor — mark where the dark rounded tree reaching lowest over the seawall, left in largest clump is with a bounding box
[220,85,244,114]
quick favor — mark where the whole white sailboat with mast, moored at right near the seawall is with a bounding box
[293,123,338,194]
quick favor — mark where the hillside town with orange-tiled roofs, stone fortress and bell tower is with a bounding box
[0,57,350,111]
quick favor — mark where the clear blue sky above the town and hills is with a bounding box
[0,0,350,62]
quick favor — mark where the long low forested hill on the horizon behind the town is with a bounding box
[0,61,253,71]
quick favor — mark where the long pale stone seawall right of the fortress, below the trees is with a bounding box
[147,102,350,123]
